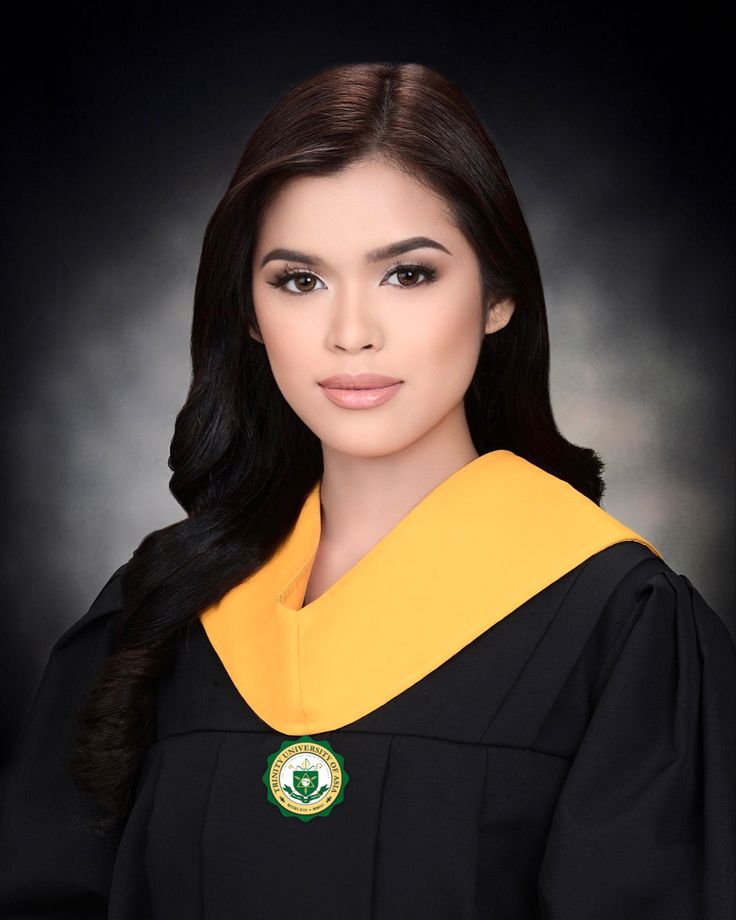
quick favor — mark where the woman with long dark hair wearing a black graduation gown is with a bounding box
[0,63,736,920]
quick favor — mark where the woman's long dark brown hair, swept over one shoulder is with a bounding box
[72,62,605,828]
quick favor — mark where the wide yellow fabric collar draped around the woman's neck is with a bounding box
[201,450,661,736]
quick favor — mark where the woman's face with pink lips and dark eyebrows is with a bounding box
[251,160,514,457]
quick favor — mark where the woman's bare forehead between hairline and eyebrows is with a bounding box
[257,161,459,253]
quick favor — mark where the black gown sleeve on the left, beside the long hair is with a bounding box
[0,563,127,920]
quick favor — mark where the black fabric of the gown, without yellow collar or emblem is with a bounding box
[0,542,736,920]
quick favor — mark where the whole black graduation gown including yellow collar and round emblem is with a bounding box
[0,450,736,920]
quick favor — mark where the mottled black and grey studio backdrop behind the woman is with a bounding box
[0,2,734,764]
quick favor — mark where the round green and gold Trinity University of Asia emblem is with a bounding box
[261,735,350,821]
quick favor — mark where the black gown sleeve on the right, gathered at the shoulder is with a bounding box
[538,568,736,920]
